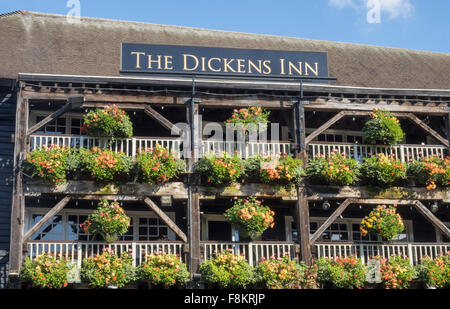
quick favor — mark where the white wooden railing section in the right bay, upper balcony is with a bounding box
[309,142,447,162]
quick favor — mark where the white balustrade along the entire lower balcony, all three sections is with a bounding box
[27,241,450,266]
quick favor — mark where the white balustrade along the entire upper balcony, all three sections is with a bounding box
[30,134,447,162]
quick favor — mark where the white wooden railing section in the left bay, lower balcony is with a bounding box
[27,241,184,266]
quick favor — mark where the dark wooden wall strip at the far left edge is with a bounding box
[0,81,16,289]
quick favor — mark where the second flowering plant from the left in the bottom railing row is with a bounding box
[81,248,136,288]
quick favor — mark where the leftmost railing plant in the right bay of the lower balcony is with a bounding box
[316,255,366,289]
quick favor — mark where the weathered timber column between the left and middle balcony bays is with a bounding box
[186,80,201,279]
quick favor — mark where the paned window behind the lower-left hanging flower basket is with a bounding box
[27,210,176,241]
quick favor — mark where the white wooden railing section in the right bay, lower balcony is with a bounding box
[315,243,450,265]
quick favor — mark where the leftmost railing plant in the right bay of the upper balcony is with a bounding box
[306,150,360,186]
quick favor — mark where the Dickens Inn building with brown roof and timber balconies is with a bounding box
[0,11,450,287]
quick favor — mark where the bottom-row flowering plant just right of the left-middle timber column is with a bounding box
[200,249,255,289]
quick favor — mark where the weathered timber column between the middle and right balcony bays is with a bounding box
[293,95,312,265]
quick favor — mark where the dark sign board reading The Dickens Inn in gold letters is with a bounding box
[121,43,328,80]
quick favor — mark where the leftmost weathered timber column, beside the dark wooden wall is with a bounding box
[8,85,28,289]
